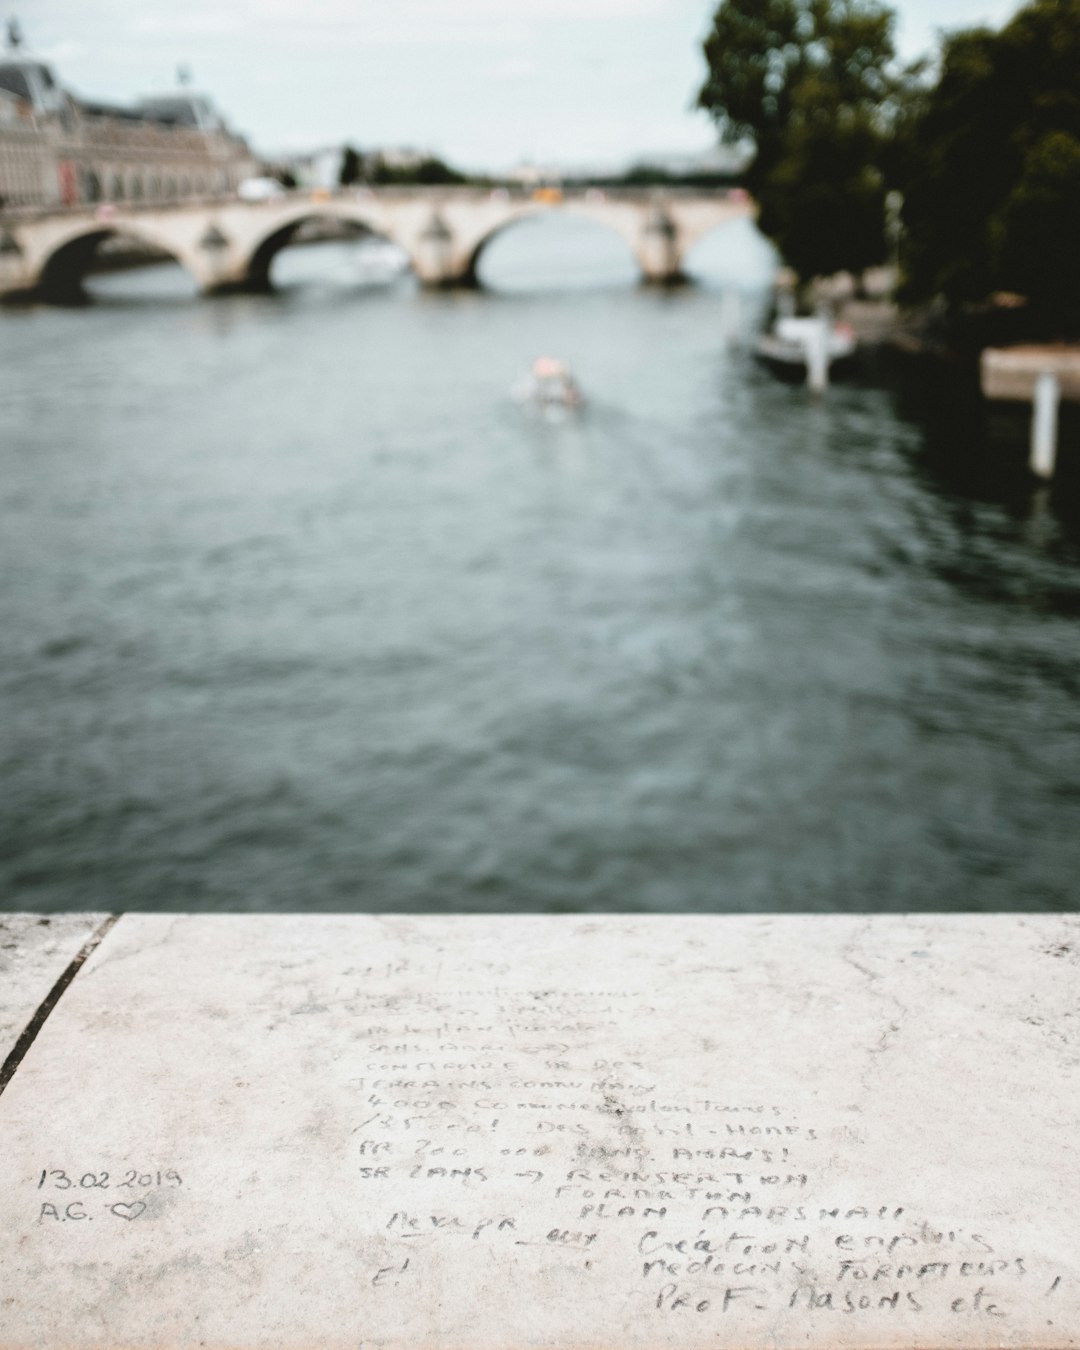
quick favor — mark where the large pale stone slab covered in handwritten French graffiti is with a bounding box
[0,915,1080,1350]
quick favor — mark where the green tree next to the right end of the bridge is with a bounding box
[698,0,905,277]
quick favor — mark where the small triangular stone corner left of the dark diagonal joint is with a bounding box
[0,914,105,1062]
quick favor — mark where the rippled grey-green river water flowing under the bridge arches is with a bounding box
[0,225,1080,911]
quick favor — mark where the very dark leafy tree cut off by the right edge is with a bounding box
[903,0,1080,332]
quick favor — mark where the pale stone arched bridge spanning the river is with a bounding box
[0,188,755,297]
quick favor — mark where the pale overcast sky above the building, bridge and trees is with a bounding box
[23,0,1017,169]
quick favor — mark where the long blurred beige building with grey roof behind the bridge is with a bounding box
[0,41,257,209]
